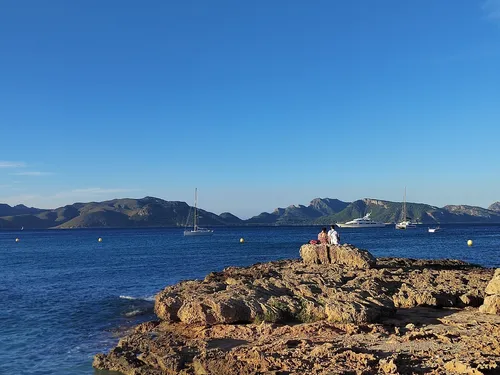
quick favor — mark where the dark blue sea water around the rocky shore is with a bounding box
[0,225,500,375]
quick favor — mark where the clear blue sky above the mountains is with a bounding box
[0,0,500,217]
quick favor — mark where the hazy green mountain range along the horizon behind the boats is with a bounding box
[0,197,500,229]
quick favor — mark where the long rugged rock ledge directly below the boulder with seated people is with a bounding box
[155,261,395,325]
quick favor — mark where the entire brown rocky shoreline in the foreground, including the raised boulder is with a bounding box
[93,244,500,375]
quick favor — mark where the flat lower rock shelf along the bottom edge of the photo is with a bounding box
[94,307,500,375]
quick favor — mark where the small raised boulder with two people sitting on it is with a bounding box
[300,244,376,268]
